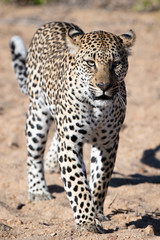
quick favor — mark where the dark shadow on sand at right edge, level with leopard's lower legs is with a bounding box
[110,145,160,187]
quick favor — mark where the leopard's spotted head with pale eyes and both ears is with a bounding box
[67,29,136,104]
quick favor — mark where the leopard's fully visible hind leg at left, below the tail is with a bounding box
[26,102,52,201]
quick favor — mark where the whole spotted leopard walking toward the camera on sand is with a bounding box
[10,22,136,233]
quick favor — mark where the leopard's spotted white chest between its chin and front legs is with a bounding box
[56,94,125,144]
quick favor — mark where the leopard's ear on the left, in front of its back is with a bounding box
[66,28,84,55]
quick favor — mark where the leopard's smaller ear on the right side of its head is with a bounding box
[120,30,136,48]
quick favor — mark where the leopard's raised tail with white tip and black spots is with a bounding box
[10,36,28,95]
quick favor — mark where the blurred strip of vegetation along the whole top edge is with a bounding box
[3,0,160,11]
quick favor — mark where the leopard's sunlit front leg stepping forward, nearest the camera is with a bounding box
[58,135,103,232]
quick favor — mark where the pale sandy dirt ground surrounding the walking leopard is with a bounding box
[0,0,160,240]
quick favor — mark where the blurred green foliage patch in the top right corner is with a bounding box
[133,0,160,11]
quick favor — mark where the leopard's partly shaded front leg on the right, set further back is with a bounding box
[90,138,118,221]
